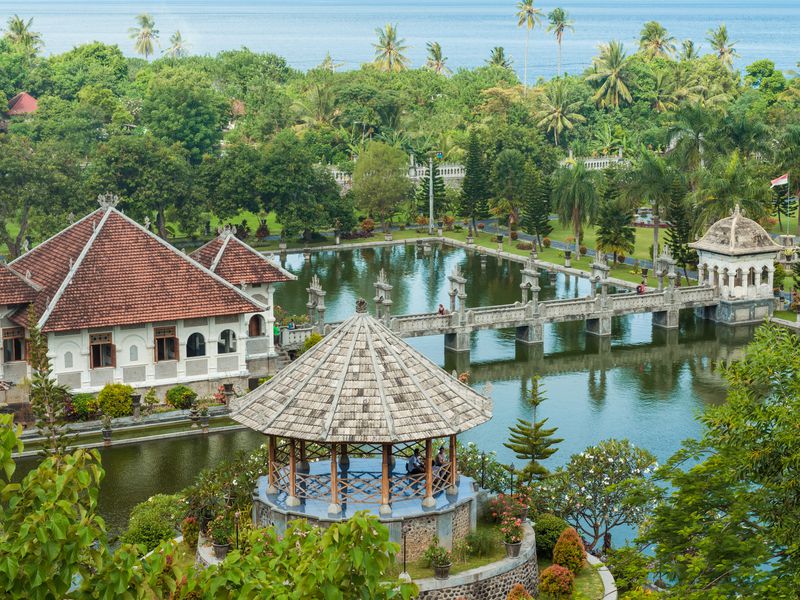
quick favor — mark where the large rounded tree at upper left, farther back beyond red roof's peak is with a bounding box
[142,69,229,164]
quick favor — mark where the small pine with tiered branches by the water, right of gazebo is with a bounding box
[503,376,564,483]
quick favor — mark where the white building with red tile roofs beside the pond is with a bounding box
[0,198,294,400]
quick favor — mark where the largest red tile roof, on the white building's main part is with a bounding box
[12,208,263,331]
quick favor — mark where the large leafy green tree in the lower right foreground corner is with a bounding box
[642,324,800,600]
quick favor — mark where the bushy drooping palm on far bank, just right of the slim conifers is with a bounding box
[553,162,600,256]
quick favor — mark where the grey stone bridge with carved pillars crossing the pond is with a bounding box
[294,250,720,353]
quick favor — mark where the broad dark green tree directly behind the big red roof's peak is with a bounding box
[89,134,198,238]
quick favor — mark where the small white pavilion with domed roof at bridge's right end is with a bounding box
[689,205,781,323]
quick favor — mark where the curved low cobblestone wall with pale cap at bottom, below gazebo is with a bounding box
[416,525,539,600]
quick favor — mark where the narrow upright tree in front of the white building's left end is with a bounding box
[27,306,69,456]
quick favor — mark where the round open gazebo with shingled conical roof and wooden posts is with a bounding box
[232,299,492,558]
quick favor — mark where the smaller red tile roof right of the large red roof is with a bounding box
[192,231,297,285]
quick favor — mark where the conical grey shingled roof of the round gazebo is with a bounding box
[232,300,492,443]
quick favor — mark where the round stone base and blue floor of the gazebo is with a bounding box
[253,475,478,562]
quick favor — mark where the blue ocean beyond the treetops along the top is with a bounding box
[0,0,800,81]
